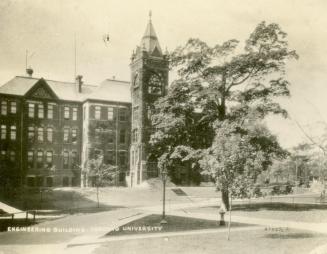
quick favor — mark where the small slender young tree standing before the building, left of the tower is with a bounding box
[86,150,117,208]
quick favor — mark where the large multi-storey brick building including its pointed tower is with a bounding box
[0,15,168,187]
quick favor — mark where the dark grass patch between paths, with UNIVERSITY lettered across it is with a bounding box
[106,214,250,236]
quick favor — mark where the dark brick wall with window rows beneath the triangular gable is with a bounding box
[0,92,82,187]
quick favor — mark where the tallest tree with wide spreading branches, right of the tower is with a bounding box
[153,22,298,207]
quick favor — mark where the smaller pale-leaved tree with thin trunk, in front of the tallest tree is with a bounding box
[200,120,286,239]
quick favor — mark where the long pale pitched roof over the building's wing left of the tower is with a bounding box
[0,76,131,103]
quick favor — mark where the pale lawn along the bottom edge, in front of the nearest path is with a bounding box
[93,227,327,254]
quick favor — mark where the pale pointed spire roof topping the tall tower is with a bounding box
[140,19,162,56]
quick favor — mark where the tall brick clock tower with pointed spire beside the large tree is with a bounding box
[130,13,169,186]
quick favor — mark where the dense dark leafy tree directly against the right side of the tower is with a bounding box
[150,81,214,184]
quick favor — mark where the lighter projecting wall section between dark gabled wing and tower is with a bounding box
[82,101,131,186]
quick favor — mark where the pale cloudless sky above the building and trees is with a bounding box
[0,0,327,147]
